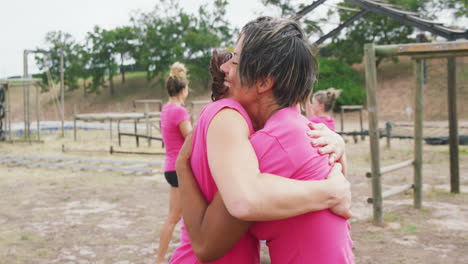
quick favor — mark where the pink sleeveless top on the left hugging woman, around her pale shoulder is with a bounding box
[169,99,260,264]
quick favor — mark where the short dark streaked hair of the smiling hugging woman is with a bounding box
[237,17,318,107]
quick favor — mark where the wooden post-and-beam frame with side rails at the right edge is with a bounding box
[364,41,468,225]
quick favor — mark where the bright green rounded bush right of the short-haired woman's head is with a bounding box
[314,57,366,111]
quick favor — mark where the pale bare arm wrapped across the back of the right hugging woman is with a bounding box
[207,109,349,221]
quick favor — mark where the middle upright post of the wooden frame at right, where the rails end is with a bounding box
[413,59,424,209]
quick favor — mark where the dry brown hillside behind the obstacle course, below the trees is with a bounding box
[6,58,468,122]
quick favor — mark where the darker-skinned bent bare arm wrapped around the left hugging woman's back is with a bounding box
[176,136,251,262]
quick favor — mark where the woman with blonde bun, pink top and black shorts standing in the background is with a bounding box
[156,62,192,264]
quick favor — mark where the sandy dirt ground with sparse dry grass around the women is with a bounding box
[0,121,468,264]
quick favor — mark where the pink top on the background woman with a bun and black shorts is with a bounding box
[161,104,190,172]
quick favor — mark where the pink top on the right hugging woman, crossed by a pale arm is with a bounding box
[250,107,354,264]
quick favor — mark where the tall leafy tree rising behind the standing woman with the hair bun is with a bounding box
[133,0,232,87]
